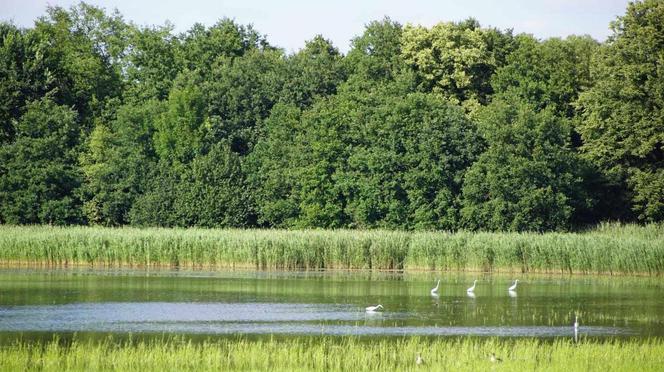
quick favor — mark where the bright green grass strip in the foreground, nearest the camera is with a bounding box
[0,337,664,372]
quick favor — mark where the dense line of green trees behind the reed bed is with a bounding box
[0,0,664,231]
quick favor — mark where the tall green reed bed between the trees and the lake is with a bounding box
[0,225,664,275]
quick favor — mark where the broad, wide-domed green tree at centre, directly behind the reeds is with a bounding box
[256,85,481,229]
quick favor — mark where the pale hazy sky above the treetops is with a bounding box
[0,0,628,53]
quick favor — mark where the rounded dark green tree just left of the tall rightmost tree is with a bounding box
[462,98,591,231]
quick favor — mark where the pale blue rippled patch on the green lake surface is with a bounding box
[0,302,632,337]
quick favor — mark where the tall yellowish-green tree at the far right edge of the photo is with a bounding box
[578,0,664,221]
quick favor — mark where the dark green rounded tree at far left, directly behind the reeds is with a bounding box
[0,98,83,224]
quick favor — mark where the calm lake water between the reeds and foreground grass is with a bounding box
[0,269,664,342]
